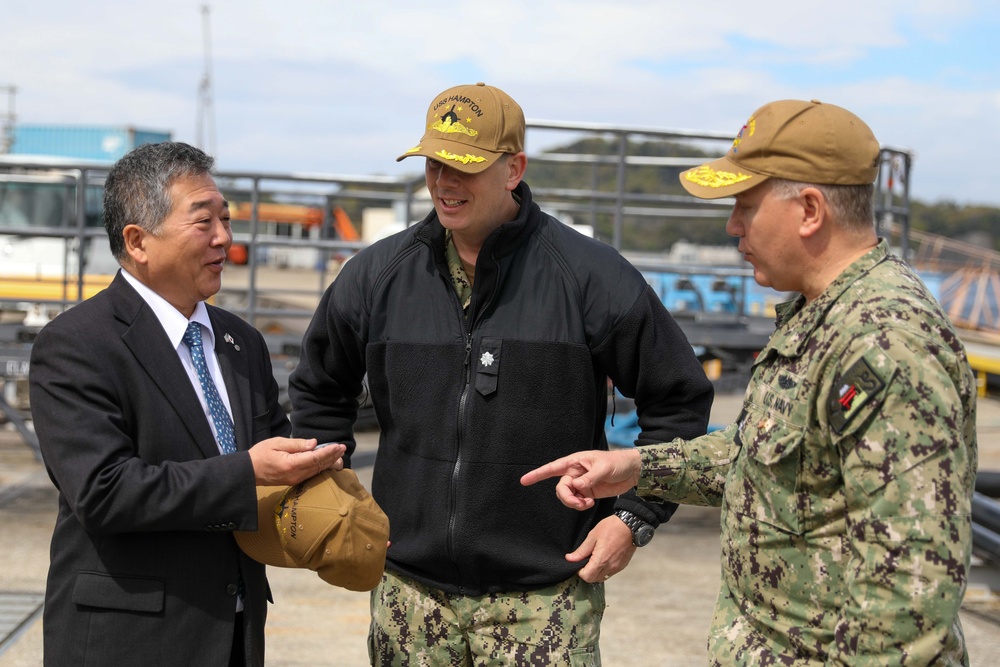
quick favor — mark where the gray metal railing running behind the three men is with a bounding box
[0,120,911,322]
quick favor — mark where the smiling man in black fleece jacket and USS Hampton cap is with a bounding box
[290,84,713,665]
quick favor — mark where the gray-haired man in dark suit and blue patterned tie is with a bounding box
[30,142,344,667]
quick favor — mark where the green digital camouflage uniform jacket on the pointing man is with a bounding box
[638,241,976,665]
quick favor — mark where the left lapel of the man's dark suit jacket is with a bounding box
[109,274,219,457]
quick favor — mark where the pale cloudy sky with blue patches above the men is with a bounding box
[0,0,1000,206]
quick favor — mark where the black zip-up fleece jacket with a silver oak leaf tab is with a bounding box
[289,182,713,595]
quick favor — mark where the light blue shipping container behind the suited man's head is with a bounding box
[10,125,170,162]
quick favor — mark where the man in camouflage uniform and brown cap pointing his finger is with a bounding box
[522,100,976,665]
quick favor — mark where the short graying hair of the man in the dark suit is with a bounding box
[104,141,215,264]
